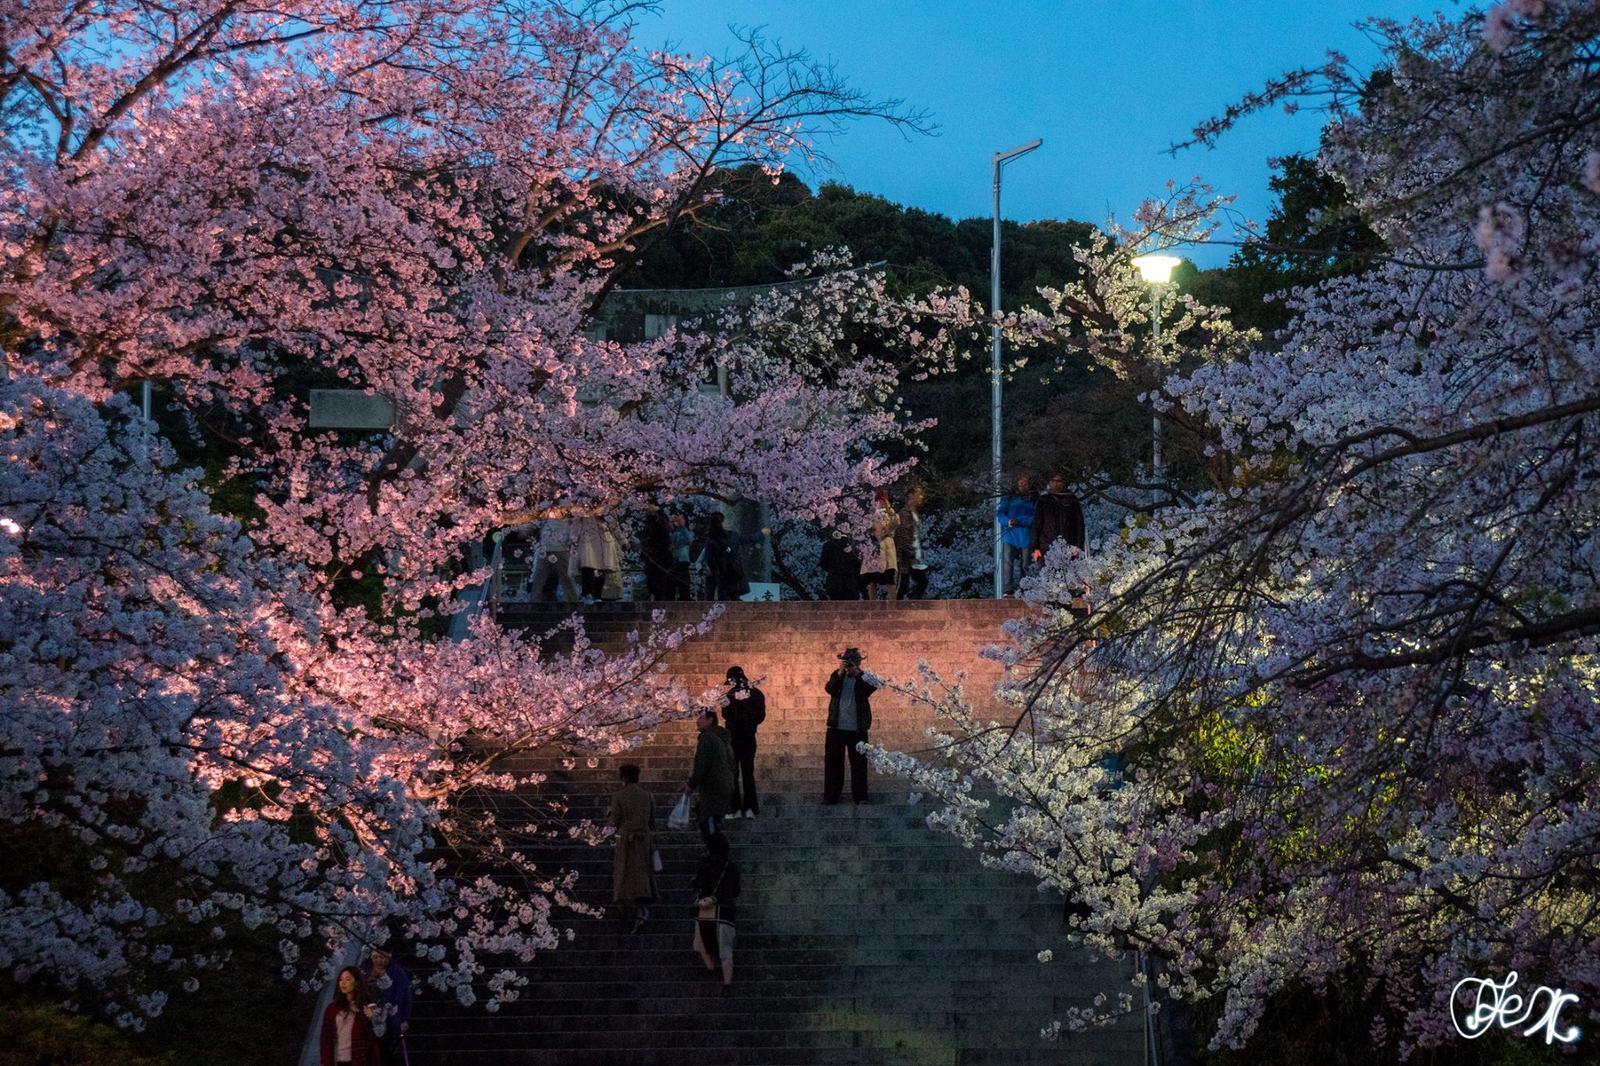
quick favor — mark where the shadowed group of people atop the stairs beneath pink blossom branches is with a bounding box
[512,506,771,603]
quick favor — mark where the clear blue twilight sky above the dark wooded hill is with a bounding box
[638,0,1462,266]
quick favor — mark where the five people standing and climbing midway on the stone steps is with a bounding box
[610,648,878,996]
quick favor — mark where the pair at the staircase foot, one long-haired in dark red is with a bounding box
[322,946,411,1066]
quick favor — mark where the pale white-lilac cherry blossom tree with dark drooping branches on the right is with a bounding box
[880,0,1600,1055]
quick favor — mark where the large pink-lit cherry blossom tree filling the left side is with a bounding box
[0,0,971,1024]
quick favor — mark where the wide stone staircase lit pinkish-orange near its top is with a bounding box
[410,600,1142,1066]
